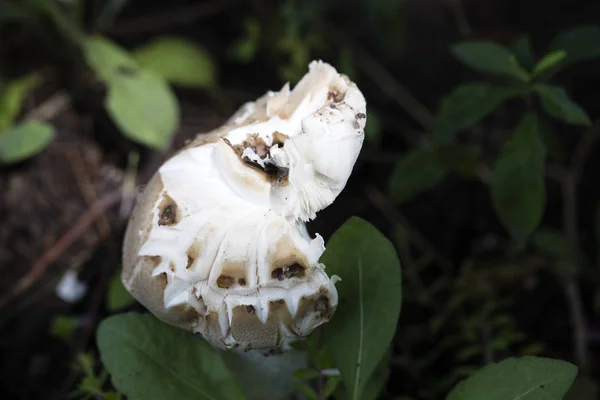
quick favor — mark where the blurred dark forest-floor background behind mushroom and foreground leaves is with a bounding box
[0,0,600,400]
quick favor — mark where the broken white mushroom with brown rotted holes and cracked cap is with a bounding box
[122,61,366,351]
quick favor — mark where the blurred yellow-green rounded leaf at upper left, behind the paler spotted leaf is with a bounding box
[134,37,216,88]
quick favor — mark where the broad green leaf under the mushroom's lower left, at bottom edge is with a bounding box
[98,313,245,400]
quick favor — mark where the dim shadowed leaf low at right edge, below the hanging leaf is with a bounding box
[532,228,585,275]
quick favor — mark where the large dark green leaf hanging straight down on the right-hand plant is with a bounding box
[491,114,546,243]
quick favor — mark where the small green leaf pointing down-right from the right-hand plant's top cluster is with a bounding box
[535,84,592,125]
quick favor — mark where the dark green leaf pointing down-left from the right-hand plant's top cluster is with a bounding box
[434,83,523,142]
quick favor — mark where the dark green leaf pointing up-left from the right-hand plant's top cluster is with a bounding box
[451,41,529,82]
